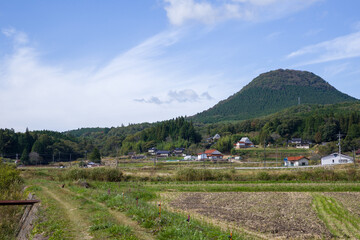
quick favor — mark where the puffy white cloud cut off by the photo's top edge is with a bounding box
[164,0,320,26]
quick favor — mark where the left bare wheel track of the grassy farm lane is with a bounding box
[42,186,92,239]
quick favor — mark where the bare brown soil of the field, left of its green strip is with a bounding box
[170,192,332,239]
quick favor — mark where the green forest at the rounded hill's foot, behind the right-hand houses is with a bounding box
[207,103,360,152]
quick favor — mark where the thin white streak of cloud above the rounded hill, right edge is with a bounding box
[287,32,360,66]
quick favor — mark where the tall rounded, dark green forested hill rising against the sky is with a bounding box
[190,69,358,123]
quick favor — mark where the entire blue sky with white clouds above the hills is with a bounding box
[0,0,360,131]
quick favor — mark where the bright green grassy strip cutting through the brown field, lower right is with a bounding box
[313,194,360,239]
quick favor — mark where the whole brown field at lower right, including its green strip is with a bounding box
[164,192,360,239]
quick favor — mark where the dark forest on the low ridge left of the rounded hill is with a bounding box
[0,117,201,165]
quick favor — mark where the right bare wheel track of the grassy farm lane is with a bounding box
[62,189,155,240]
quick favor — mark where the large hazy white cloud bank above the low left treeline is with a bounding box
[0,30,219,131]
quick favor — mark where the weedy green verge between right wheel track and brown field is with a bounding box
[71,182,253,240]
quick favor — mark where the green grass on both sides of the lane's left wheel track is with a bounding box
[29,181,137,240]
